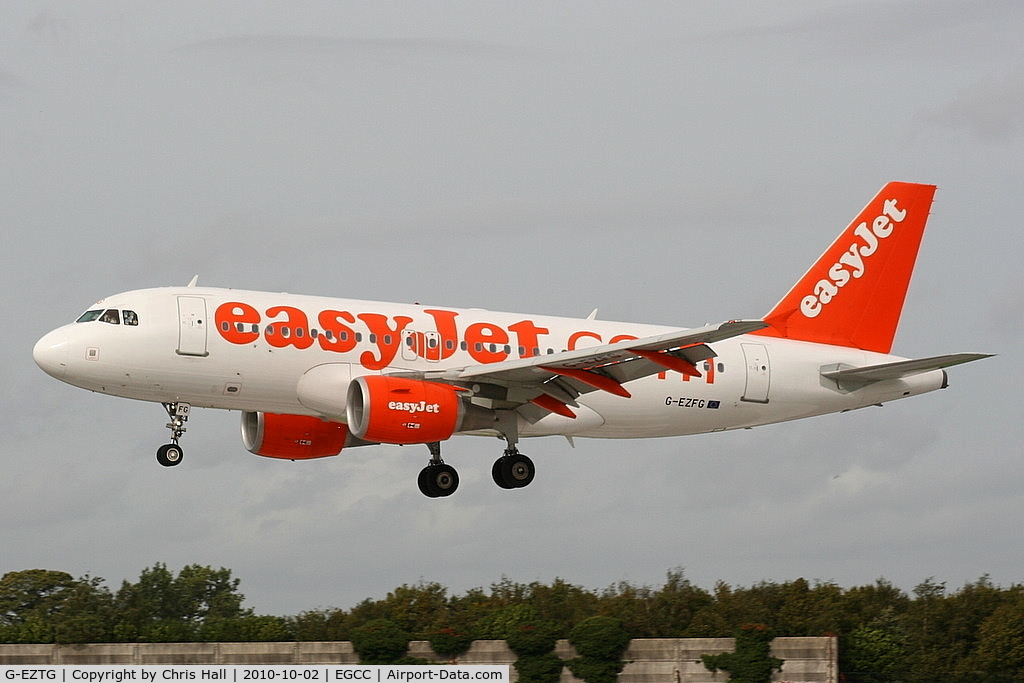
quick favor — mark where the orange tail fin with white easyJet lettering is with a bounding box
[760,182,935,353]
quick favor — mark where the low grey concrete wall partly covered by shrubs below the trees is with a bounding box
[0,638,839,683]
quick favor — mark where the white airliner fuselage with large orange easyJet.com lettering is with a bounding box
[50,288,944,438]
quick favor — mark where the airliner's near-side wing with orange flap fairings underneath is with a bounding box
[395,321,768,419]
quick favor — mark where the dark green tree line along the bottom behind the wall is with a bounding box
[0,563,1024,682]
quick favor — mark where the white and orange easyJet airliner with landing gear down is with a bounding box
[33,182,987,498]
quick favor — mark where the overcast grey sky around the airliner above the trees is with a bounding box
[0,1,1024,614]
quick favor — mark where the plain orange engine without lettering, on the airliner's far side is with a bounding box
[242,412,348,460]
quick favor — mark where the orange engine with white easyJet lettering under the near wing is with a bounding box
[345,375,494,443]
